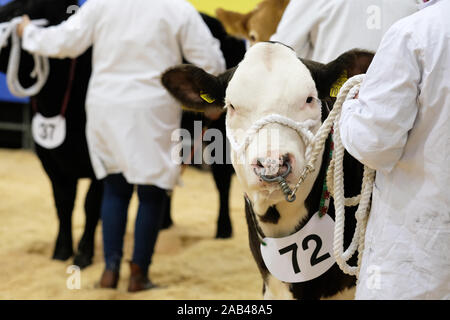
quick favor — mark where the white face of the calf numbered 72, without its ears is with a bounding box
[225,43,321,212]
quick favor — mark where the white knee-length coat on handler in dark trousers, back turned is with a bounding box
[23,0,225,189]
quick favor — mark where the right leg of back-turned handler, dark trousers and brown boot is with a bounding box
[128,185,168,292]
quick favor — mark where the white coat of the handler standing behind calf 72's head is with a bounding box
[271,0,417,63]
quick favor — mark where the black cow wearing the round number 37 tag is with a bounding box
[0,0,103,268]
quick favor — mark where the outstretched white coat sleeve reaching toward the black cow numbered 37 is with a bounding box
[22,0,99,58]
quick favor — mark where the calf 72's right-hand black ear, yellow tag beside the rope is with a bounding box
[301,49,374,99]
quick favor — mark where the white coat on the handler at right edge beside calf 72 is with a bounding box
[340,0,450,299]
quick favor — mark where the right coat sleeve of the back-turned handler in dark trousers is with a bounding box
[178,3,225,75]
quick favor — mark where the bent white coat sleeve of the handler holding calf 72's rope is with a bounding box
[340,23,422,172]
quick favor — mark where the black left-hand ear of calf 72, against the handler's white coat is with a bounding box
[161,64,235,112]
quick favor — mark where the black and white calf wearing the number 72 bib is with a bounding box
[162,42,373,299]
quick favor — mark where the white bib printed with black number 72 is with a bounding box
[261,212,335,283]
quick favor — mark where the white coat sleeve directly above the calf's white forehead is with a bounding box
[270,0,322,58]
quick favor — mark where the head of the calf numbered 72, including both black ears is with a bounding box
[162,42,373,222]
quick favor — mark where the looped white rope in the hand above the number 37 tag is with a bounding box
[0,17,50,97]
